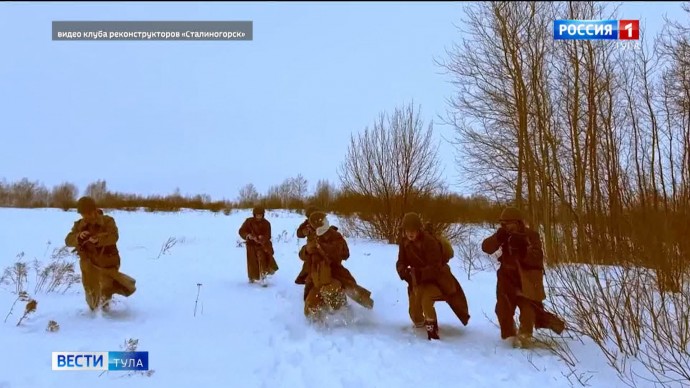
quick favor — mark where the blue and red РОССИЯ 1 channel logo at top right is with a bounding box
[553,19,640,40]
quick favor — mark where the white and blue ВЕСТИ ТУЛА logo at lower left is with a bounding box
[52,352,149,371]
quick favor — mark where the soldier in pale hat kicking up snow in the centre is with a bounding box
[299,211,374,316]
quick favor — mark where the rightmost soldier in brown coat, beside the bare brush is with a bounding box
[482,207,565,347]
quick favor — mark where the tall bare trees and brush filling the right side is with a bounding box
[441,2,690,384]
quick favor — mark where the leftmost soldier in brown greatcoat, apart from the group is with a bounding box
[65,197,136,311]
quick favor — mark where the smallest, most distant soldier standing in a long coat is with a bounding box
[239,206,278,283]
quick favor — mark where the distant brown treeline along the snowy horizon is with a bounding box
[0,176,502,223]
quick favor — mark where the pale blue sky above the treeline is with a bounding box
[0,2,680,199]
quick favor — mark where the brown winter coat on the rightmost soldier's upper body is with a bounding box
[482,227,546,302]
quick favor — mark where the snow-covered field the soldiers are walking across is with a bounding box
[0,209,620,388]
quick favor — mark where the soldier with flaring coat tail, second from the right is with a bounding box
[396,213,470,340]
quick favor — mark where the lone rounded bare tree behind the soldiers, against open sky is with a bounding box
[339,104,442,243]
